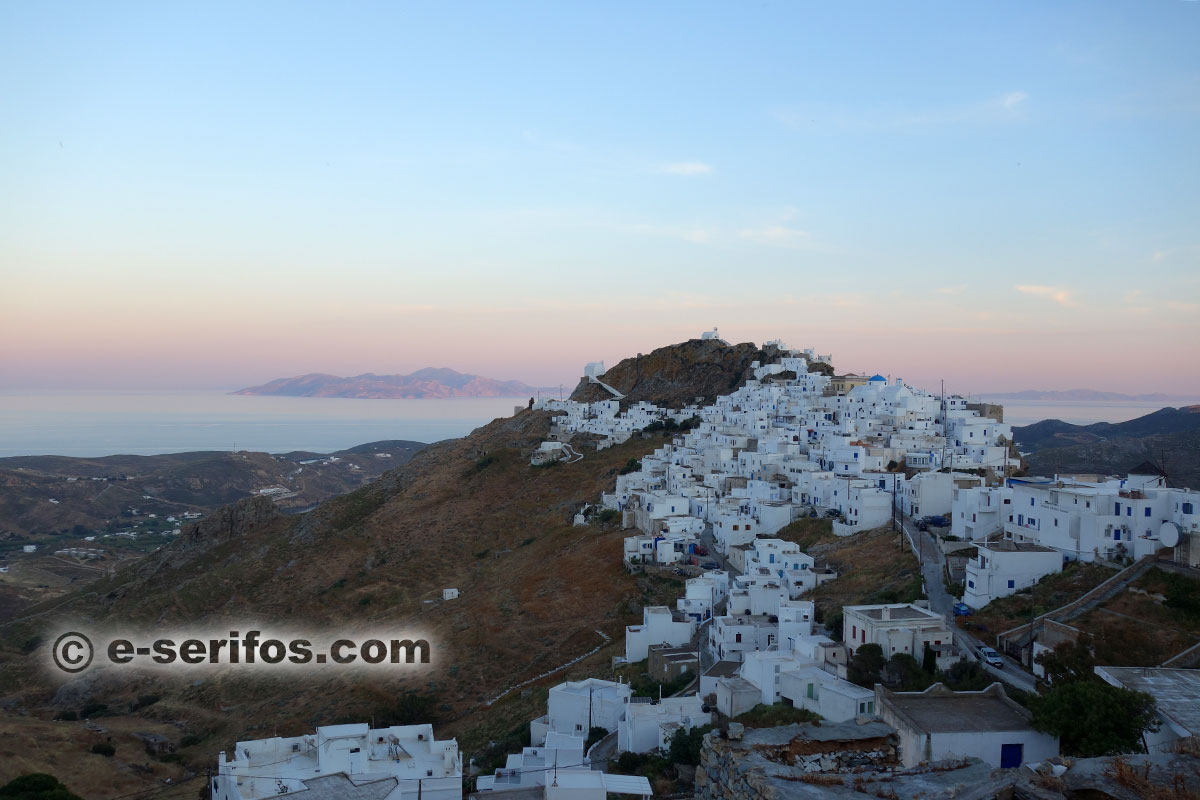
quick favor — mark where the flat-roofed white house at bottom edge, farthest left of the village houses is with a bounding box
[211,722,462,800]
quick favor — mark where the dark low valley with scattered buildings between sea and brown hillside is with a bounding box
[0,441,425,619]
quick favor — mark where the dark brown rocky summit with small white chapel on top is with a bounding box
[571,339,801,408]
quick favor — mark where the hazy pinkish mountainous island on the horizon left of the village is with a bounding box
[230,367,550,399]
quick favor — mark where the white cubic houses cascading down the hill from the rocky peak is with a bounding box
[212,331,1200,800]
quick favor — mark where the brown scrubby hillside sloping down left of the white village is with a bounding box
[0,411,661,796]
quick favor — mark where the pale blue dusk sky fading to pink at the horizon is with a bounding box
[0,0,1200,396]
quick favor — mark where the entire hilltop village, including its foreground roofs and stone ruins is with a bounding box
[211,331,1200,800]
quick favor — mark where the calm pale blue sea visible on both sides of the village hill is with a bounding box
[0,390,1187,457]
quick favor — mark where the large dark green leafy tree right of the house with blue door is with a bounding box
[1030,680,1158,758]
